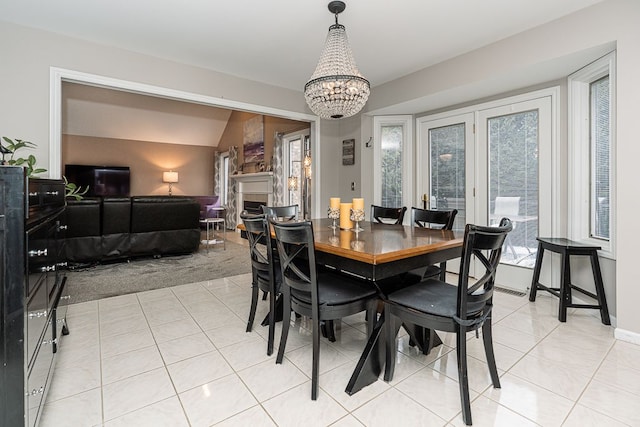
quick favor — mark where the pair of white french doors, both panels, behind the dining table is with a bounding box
[417,95,553,291]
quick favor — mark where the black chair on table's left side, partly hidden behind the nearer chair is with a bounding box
[240,213,281,356]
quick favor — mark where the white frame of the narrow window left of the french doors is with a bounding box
[373,115,414,224]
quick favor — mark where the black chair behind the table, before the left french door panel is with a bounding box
[403,207,458,283]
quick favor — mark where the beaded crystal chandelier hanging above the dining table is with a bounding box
[304,1,370,119]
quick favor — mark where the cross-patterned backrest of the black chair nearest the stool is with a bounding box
[457,218,513,319]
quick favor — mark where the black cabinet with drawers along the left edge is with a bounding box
[0,166,68,426]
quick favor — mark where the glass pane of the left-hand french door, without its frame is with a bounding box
[427,123,466,230]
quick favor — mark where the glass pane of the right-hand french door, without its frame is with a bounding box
[487,110,539,267]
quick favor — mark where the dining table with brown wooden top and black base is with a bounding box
[238,218,463,395]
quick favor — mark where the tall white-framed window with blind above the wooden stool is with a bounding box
[569,53,615,257]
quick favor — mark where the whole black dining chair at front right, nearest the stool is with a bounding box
[384,218,513,425]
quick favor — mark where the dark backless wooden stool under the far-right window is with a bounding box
[529,237,611,325]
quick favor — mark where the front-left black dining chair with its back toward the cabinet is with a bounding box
[269,219,378,400]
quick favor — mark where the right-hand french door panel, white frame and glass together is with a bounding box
[476,96,553,291]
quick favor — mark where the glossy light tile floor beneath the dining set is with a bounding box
[40,275,640,427]
